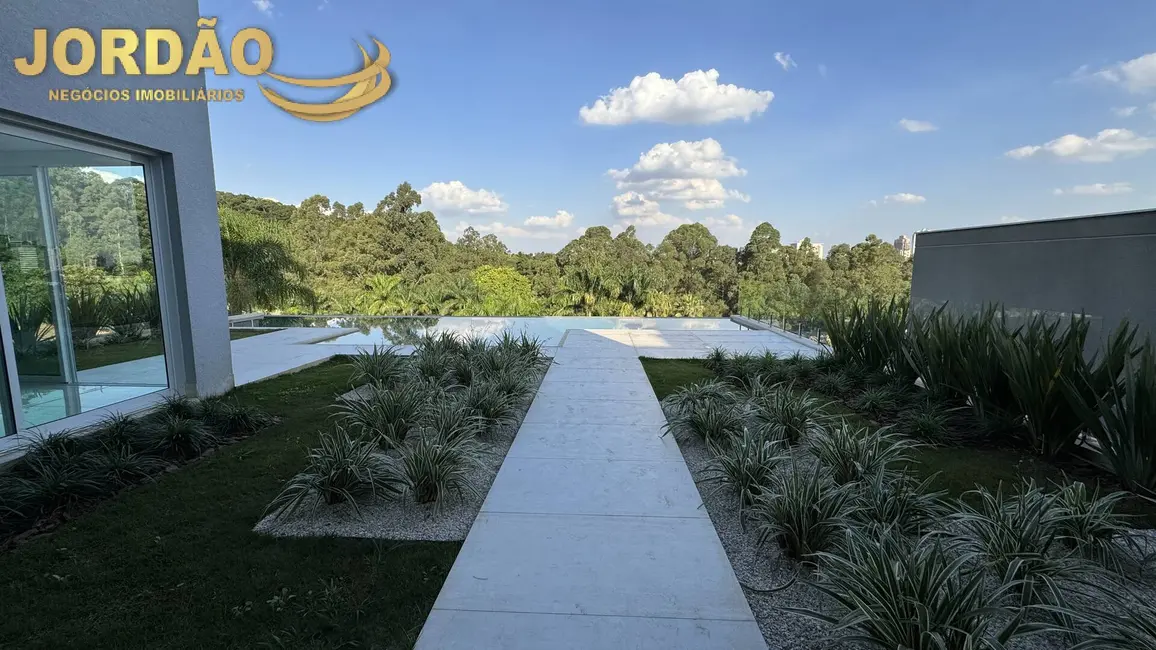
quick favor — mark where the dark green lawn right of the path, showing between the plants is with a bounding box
[642,359,1156,518]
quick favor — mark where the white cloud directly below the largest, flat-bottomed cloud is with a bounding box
[607,138,750,209]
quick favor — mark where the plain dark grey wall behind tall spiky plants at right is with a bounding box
[911,210,1156,348]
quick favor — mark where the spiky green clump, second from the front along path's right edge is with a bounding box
[754,464,855,562]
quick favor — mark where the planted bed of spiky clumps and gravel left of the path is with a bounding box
[254,335,549,541]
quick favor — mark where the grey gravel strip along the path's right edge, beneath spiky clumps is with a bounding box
[668,402,1156,650]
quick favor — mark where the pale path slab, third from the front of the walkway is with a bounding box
[482,458,707,517]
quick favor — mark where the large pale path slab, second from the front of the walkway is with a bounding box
[430,511,754,615]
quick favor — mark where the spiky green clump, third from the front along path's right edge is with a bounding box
[702,429,786,525]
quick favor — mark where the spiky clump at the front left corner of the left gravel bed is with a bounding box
[266,427,407,519]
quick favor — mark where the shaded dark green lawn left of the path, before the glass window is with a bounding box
[0,361,460,650]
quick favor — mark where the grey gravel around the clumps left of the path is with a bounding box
[253,370,546,541]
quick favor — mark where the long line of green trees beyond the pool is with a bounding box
[218,183,911,318]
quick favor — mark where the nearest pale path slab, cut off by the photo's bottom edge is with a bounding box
[421,610,766,650]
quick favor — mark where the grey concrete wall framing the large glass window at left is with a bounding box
[0,0,232,394]
